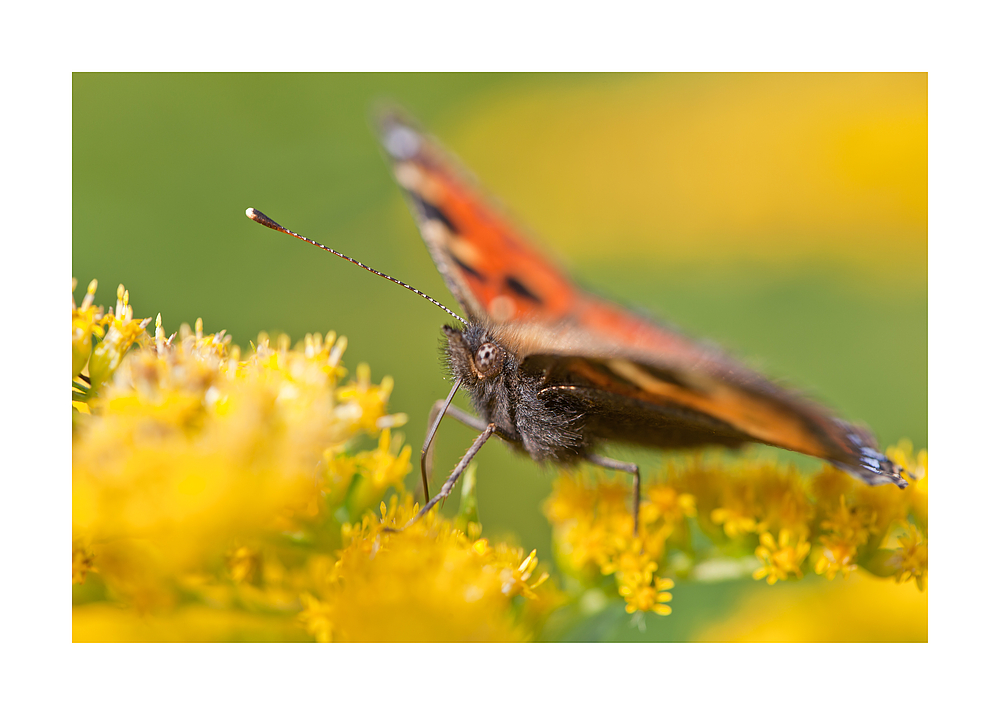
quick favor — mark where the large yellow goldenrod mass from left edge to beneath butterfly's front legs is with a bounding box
[73,282,558,641]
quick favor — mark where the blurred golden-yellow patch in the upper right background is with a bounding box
[451,74,927,271]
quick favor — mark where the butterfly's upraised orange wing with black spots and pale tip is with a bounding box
[380,114,729,368]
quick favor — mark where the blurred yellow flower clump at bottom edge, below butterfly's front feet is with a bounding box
[303,497,546,642]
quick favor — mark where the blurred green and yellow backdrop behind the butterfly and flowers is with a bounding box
[73,74,927,640]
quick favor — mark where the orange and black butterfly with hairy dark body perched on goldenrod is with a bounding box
[247,111,907,528]
